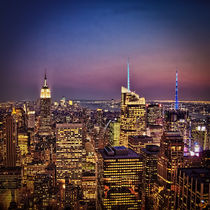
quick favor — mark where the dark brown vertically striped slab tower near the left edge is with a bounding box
[5,114,17,167]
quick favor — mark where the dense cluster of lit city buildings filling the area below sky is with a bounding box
[0,68,210,210]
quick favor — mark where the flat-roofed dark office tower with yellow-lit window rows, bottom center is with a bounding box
[98,146,143,209]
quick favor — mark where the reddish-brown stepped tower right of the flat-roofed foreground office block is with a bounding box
[158,131,184,209]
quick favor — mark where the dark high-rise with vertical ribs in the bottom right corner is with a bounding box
[177,168,210,210]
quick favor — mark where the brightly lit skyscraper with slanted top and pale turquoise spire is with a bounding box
[119,61,146,147]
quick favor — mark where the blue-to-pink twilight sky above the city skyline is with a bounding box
[0,0,210,101]
